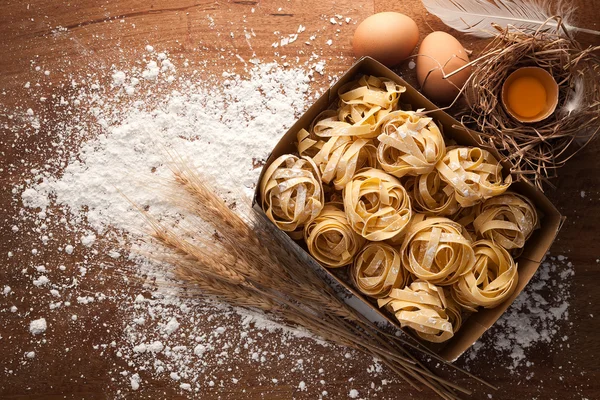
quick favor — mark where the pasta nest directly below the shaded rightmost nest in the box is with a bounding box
[452,240,519,311]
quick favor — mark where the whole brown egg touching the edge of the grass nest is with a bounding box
[417,32,471,104]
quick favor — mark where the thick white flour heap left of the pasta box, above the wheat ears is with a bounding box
[22,60,309,234]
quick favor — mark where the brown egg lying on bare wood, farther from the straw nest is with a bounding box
[352,12,419,67]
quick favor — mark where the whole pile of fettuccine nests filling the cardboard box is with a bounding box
[260,75,539,342]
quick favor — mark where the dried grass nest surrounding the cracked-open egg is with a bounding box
[461,17,600,189]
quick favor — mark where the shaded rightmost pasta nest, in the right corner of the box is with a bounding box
[473,192,539,250]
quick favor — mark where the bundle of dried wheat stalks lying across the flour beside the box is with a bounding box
[137,160,491,399]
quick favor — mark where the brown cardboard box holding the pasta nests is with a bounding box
[254,57,563,361]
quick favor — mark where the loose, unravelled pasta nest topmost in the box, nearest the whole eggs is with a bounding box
[313,75,406,139]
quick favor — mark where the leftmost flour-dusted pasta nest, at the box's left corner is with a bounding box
[260,154,324,239]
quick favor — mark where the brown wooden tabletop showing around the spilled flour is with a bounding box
[0,0,600,399]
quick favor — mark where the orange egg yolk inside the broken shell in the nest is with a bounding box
[507,76,546,118]
